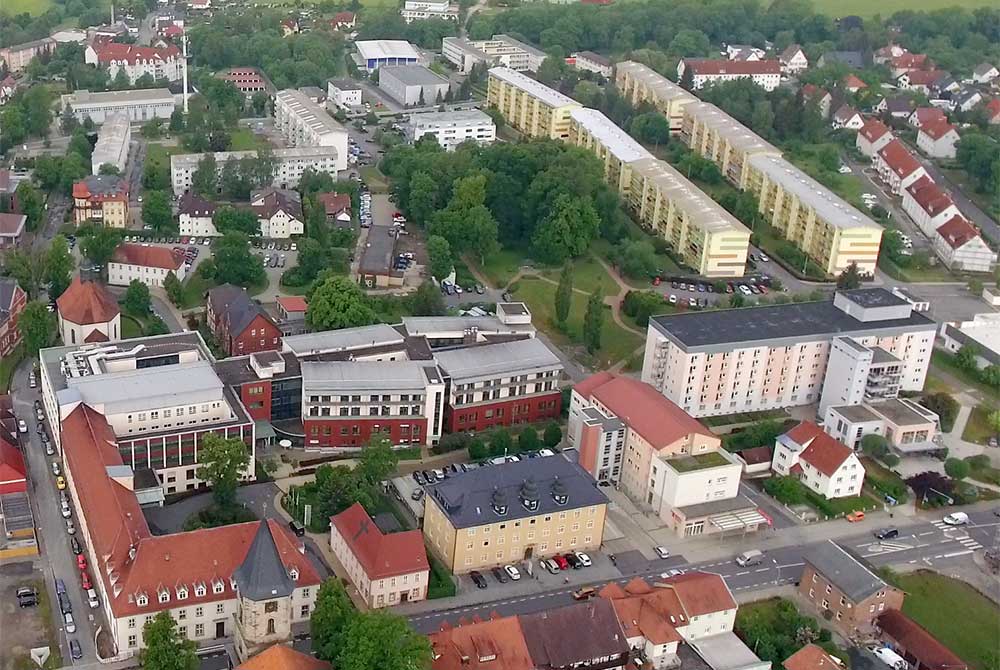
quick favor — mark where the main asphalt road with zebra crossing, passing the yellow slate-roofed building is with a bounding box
[409,510,1000,633]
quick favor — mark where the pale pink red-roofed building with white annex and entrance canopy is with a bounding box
[567,372,763,535]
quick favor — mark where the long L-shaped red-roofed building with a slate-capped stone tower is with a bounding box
[61,403,320,659]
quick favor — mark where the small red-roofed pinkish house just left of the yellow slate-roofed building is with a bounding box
[330,503,430,607]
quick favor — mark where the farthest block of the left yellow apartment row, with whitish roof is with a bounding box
[486,67,582,140]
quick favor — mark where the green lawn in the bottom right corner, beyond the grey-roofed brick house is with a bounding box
[893,570,1000,670]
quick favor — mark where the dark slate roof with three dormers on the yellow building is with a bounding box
[427,454,608,528]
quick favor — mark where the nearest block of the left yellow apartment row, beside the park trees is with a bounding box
[623,156,750,277]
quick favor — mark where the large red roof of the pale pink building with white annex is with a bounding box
[576,373,717,449]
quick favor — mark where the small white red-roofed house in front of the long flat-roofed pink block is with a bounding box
[771,421,865,498]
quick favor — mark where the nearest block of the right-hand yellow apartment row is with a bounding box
[745,154,882,276]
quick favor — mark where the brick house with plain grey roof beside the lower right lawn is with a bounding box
[798,540,903,637]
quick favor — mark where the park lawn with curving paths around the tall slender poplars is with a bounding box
[514,277,643,369]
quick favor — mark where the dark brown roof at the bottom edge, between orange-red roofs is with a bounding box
[521,598,629,670]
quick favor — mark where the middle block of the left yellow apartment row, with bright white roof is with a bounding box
[567,107,653,195]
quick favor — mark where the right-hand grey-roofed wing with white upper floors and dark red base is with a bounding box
[434,338,563,432]
